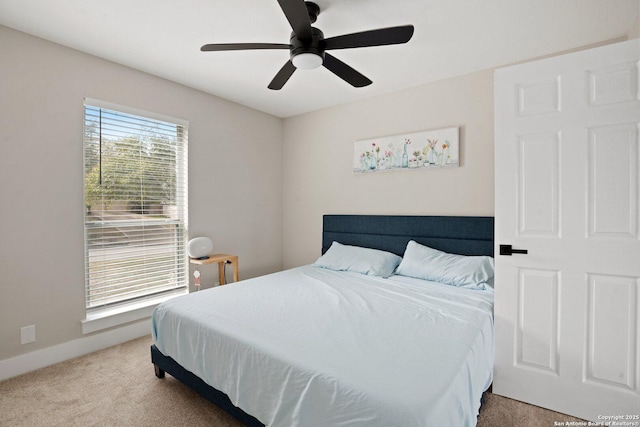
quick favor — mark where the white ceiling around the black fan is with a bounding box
[0,0,640,117]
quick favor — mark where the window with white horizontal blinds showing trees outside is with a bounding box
[84,99,189,309]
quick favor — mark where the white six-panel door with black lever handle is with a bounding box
[493,40,640,425]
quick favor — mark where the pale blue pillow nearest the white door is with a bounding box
[396,240,493,289]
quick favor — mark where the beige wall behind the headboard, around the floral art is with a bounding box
[283,70,494,268]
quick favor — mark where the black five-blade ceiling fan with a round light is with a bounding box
[200,0,413,90]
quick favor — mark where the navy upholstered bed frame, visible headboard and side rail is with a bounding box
[151,215,494,426]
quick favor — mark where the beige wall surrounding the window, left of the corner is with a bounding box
[0,26,282,361]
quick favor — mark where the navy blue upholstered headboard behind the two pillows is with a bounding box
[322,215,494,256]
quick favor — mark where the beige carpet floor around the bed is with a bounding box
[0,337,579,427]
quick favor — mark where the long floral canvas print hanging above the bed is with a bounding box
[353,127,460,174]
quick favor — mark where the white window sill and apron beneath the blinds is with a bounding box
[81,288,189,335]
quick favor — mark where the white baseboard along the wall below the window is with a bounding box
[0,318,151,381]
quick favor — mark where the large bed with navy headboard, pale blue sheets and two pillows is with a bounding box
[151,215,494,426]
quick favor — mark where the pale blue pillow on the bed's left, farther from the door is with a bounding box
[312,242,402,277]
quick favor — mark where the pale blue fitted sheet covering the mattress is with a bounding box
[152,266,493,427]
